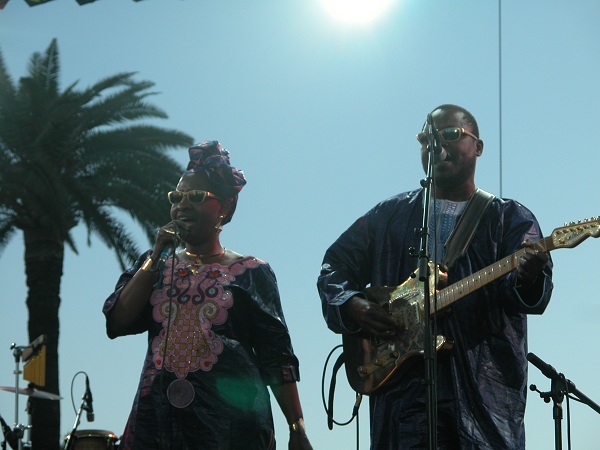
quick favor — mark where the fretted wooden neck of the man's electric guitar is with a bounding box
[431,236,555,312]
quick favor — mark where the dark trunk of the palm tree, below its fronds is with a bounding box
[24,228,64,450]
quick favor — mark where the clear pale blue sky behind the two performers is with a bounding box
[0,0,600,450]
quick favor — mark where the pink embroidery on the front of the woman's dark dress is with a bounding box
[150,258,264,378]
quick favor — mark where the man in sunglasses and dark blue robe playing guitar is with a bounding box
[317,105,552,450]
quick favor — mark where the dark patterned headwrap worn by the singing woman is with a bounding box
[185,141,246,225]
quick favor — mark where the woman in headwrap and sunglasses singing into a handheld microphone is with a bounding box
[103,141,312,450]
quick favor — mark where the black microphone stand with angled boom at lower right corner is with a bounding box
[527,353,600,450]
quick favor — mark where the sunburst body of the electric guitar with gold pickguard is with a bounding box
[342,264,450,395]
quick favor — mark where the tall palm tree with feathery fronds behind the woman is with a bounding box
[0,39,192,450]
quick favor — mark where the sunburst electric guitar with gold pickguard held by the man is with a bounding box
[342,216,600,395]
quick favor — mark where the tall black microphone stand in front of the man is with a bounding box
[418,114,437,450]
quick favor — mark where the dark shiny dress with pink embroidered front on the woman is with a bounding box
[103,254,299,450]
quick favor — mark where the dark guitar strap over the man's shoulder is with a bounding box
[442,188,494,268]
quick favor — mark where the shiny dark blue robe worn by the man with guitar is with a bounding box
[317,189,552,450]
